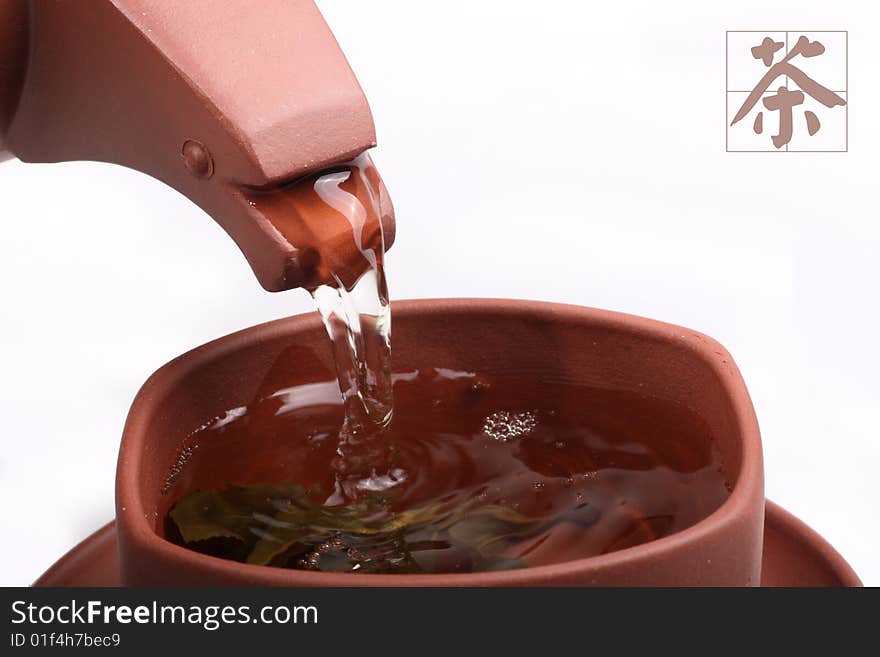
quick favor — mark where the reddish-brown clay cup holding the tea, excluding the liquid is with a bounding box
[117,299,764,586]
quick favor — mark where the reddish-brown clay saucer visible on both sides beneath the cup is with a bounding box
[34,500,862,587]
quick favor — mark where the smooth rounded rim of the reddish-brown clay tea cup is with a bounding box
[116,298,764,587]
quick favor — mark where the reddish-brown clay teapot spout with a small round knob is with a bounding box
[0,0,394,291]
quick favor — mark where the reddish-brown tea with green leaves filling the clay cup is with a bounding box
[162,368,728,573]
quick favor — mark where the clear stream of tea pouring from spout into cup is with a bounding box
[242,154,394,504]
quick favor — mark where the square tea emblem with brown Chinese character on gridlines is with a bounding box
[726,30,849,153]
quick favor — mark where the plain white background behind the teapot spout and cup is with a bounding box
[0,0,880,585]
